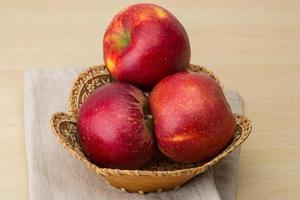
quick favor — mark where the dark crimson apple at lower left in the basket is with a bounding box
[77,83,155,169]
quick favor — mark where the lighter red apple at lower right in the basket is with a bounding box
[150,72,236,162]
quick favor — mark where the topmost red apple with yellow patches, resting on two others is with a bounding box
[103,4,191,88]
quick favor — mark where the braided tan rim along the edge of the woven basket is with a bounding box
[51,64,252,177]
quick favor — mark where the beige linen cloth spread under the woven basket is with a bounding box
[24,67,243,200]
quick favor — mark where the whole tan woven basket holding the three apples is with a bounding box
[51,64,251,194]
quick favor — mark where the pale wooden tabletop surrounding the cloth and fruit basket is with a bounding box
[0,0,300,200]
